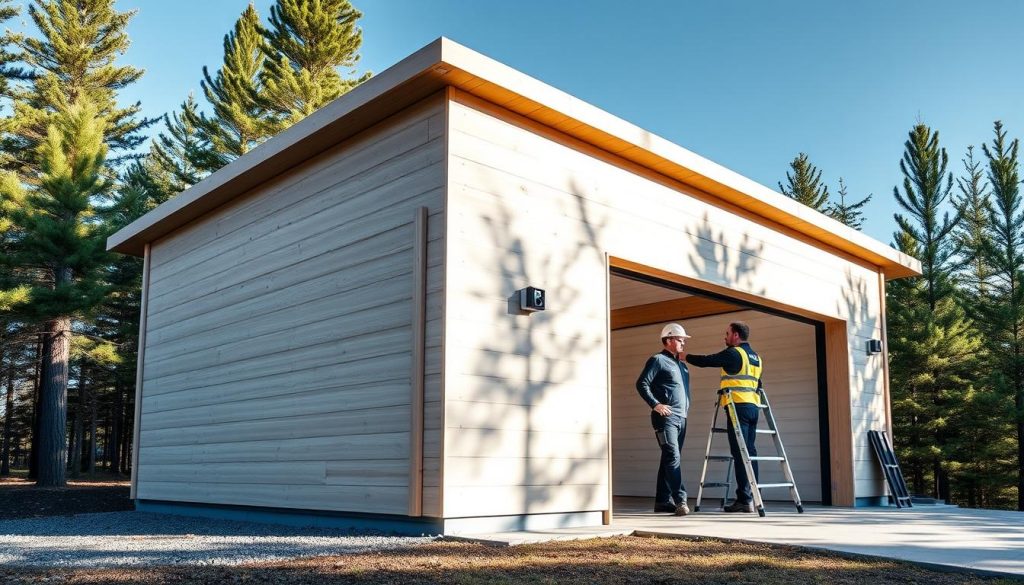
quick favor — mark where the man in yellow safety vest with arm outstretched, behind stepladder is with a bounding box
[682,321,762,512]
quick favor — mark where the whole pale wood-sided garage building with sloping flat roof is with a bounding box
[109,39,920,533]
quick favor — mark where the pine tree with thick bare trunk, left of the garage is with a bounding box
[6,100,108,486]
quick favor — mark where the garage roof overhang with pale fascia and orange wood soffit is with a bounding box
[108,38,921,279]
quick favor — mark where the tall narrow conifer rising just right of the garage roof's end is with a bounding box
[889,124,970,499]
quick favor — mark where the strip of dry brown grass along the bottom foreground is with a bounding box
[0,537,1011,585]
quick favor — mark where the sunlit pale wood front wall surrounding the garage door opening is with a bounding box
[444,91,885,516]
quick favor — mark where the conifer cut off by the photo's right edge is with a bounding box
[982,122,1024,510]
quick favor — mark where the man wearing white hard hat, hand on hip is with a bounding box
[637,323,690,516]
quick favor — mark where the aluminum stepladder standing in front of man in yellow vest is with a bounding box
[694,388,804,517]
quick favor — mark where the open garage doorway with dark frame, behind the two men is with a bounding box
[609,267,831,510]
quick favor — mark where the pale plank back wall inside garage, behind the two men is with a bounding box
[611,310,821,502]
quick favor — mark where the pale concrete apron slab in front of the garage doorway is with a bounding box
[457,502,1024,577]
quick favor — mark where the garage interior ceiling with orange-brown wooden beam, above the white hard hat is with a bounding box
[610,275,746,329]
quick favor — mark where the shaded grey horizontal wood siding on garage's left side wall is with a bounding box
[138,94,446,515]
